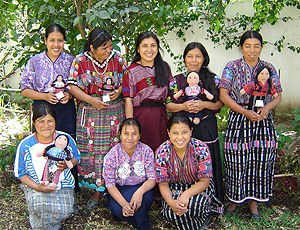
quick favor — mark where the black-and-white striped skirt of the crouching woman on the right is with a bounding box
[162,181,223,230]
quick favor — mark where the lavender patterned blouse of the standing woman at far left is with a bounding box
[20,52,74,92]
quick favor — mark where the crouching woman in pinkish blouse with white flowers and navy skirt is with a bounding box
[103,118,155,230]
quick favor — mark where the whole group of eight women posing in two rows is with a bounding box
[15,24,282,229]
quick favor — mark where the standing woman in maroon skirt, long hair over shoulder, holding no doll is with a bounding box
[123,31,172,152]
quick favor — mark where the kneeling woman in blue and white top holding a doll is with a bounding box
[14,104,80,229]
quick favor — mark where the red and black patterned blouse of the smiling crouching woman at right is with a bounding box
[155,138,212,183]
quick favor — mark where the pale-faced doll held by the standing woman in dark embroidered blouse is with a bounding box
[173,71,214,125]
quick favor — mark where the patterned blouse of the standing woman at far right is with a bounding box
[219,58,282,105]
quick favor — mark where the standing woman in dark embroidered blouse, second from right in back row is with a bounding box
[166,42,224,202]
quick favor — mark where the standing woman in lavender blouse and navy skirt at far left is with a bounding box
[20,24,80,192]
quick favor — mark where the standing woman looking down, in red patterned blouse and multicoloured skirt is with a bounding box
[69,28,127,210]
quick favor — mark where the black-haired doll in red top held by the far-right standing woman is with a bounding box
[240,66,278,109]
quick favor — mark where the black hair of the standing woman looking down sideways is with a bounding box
[84,27,112,51]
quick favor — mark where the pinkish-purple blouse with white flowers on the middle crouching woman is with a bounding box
[103,142,155,187]
